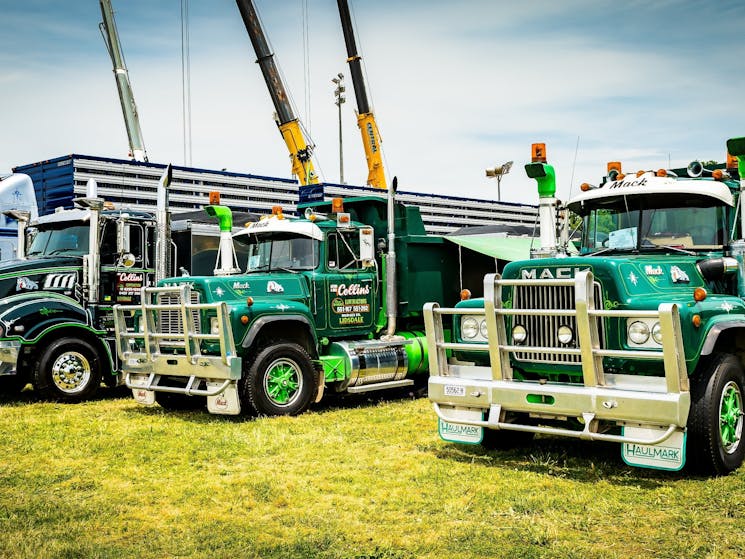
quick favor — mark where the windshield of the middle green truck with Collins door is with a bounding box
[241,235,320,273]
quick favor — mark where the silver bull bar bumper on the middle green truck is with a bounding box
[114,285,242,415]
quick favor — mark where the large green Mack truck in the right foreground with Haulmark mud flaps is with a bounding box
[424,138,745,475]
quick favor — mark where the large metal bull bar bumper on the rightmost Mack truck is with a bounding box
[424,272,691,445]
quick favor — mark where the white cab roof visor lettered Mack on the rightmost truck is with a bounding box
[567,173,735,208]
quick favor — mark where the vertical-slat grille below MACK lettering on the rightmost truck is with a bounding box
[512,282,605,363]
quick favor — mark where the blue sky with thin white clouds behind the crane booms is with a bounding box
[0,0,745,203]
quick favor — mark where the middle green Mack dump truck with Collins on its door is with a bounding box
[114,180,495,415]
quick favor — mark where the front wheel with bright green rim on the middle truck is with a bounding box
[243,342,318,415]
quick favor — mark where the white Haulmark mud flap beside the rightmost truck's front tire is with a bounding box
[621,427,687,471]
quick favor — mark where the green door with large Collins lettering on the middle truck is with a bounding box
[324,229,378,335]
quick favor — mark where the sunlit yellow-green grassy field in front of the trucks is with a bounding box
[0,393,745,559]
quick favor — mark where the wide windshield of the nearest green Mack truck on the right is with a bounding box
[580,197,727,254]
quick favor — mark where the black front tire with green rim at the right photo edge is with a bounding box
[686,353,745,475]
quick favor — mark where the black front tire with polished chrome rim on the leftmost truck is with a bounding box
[31,337,102,402]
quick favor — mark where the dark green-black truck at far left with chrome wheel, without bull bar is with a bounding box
[0,167,251,402]
